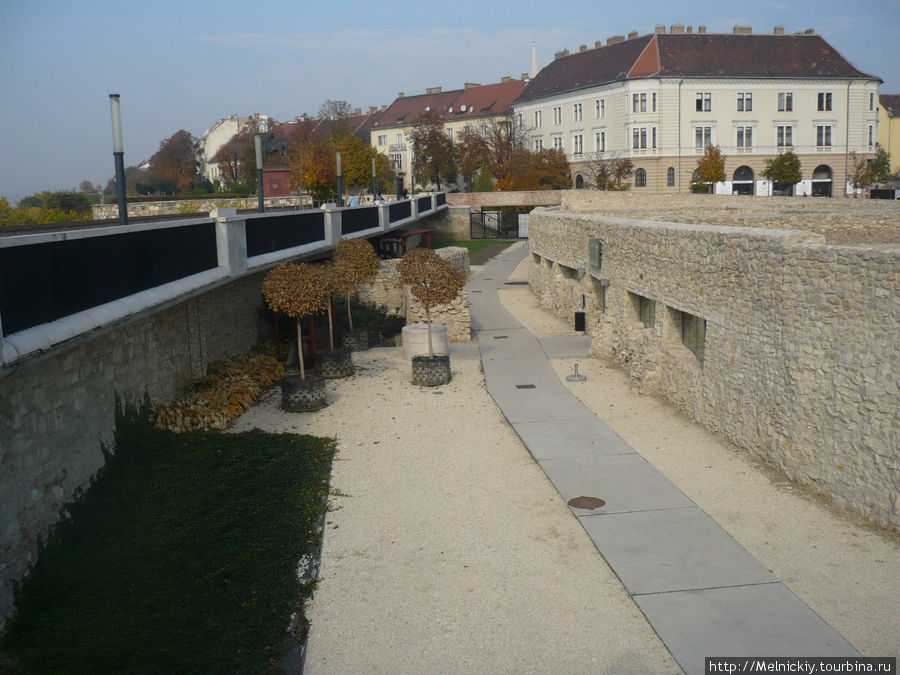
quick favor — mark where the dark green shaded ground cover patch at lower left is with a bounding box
[2,404,334,672]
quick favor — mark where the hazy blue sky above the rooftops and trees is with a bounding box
[0,0,900,201]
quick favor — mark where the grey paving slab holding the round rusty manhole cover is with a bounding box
[538,452,696,516]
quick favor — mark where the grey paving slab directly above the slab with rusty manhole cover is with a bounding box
[513,415,637,462]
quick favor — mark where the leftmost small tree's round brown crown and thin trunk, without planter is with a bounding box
[262,263,331,380]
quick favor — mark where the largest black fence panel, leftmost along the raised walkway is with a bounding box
[0,222,218,335]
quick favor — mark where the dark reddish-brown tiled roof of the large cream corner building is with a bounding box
[518,33,878,103]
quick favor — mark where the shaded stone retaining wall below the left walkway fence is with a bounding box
[0,275,267,618]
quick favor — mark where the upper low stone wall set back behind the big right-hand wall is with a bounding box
[561,190,900,244]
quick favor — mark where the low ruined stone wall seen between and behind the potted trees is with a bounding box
[359,246,472,342]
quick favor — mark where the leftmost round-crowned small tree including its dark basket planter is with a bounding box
[263,263,330,412]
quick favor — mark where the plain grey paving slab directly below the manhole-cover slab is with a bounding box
[579,507,777,594]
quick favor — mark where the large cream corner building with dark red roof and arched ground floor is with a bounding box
[513,25,881,196]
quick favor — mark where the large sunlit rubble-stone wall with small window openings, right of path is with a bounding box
[529,207,900,530]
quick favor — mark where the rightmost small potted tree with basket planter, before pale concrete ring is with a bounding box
[397,248,466,387]
